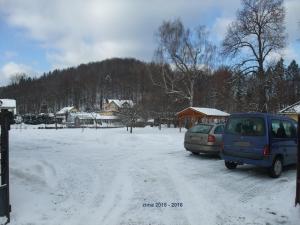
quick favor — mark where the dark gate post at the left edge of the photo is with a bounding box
[0,109,13,223]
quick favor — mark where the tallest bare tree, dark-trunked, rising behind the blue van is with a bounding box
[223,0,286,111]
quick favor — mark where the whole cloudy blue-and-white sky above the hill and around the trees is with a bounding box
[0,0,300,85]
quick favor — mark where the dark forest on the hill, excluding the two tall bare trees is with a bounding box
[0,58,300,114]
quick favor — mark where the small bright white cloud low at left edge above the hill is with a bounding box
[0,62,36,86]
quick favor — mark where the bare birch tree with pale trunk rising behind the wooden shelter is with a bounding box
[152,19,216,106]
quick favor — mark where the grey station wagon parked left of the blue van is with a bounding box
[184,123,225,154]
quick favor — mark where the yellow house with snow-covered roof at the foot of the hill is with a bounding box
[101,99,134,116]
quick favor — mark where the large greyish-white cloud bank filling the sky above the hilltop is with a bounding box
[0,0,244,67]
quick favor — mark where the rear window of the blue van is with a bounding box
[225,117,266,136]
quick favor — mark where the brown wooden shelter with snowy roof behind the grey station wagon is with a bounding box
[176,107,230,128]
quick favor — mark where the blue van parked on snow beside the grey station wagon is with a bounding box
[221,113,297,178]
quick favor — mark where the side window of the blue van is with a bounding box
[271,120,297,138]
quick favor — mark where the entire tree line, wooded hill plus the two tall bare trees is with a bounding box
[0,0,300,114]
